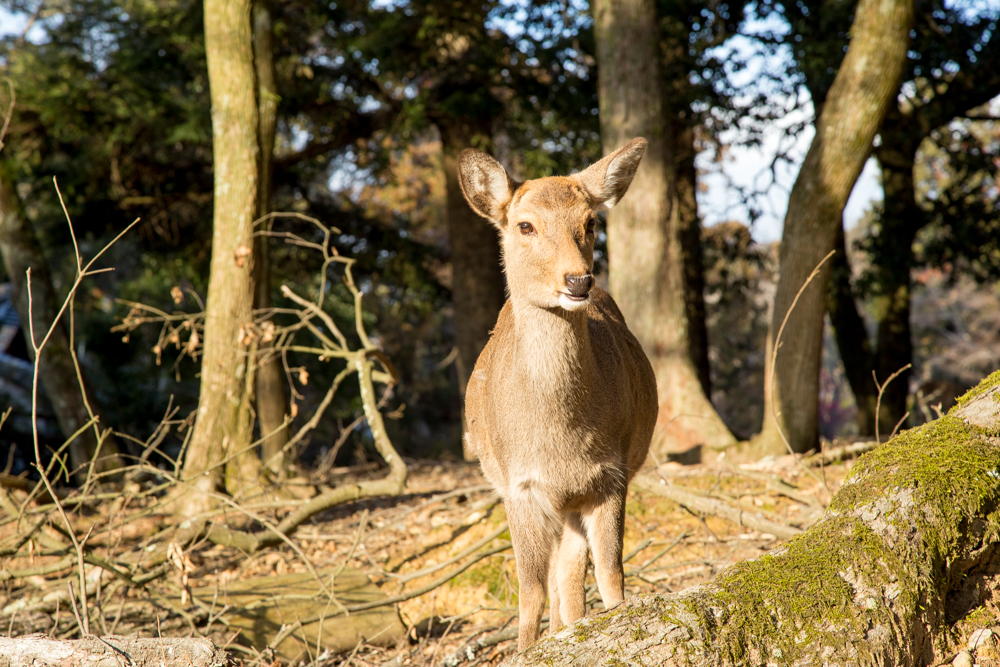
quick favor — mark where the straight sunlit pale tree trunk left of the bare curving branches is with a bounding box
[177,0,260,514]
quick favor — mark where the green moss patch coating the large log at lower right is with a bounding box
[696,414,1000,664]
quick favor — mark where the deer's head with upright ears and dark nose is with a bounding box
[458,138,646,311]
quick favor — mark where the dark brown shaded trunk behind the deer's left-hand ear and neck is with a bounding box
[438,119,506,460]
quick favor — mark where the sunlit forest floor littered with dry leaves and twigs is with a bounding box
[0,453,868,667]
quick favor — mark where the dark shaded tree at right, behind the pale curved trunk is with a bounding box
[829,2,1000,436]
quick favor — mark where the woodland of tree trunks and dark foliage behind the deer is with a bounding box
[0,0,1000,658]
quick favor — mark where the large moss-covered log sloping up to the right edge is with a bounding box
[510,371,1000,666]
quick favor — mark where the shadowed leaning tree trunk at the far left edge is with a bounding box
[0,180,122,483]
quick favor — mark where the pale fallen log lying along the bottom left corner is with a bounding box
[0,635,235,667]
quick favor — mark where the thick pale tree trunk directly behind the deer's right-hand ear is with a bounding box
[593,0,735,457]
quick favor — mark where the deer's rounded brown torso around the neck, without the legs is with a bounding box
[466,289,657,505]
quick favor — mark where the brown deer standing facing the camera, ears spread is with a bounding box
[458,138,658,651]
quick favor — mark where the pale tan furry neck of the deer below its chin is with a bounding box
[512,303,594,400]
